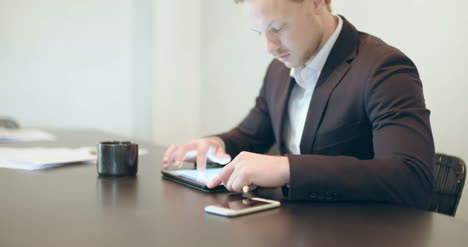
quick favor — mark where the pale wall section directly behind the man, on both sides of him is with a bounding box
[200,0,468,220]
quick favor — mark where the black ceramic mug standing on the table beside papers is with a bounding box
[97,141,138,177]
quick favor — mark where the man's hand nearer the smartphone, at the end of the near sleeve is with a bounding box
[207,152,289,192]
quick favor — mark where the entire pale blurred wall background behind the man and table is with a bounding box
[0,0,468,220]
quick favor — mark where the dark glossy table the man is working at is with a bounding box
[0,130,468,247]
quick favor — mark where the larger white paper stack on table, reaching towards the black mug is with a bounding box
[0,147,97,170]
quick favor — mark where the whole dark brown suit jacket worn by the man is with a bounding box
[219,17,434,208]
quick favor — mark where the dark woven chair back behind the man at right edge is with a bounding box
[429,153,466,216]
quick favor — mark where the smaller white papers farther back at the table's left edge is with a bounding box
[0,128,56,142]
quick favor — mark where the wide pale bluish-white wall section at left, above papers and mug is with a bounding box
[0,0,153,140]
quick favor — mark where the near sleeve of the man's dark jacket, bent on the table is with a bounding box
[288,54,435,208]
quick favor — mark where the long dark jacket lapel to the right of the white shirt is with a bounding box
[300,16,359,154]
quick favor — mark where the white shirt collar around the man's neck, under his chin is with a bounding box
[290,16,343,89]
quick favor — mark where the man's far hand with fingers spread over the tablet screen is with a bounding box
[163,137,231,173]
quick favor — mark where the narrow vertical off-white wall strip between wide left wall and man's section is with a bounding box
[152,0,202,145]
